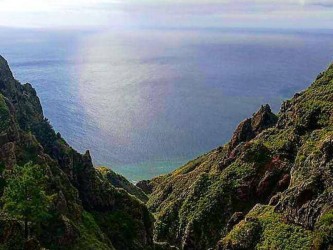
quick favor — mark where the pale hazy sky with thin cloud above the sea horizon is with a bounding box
[0,0,333,29]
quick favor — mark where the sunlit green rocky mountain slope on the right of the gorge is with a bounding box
[143,65,333,249]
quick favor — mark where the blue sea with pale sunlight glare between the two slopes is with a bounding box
[0,28,333,181]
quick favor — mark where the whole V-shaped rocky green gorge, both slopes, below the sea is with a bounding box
[0,57,333,250]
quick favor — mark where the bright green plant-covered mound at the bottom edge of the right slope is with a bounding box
[222,205,314,250]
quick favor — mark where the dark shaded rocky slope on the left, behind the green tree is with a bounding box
[0,57,155,249]
